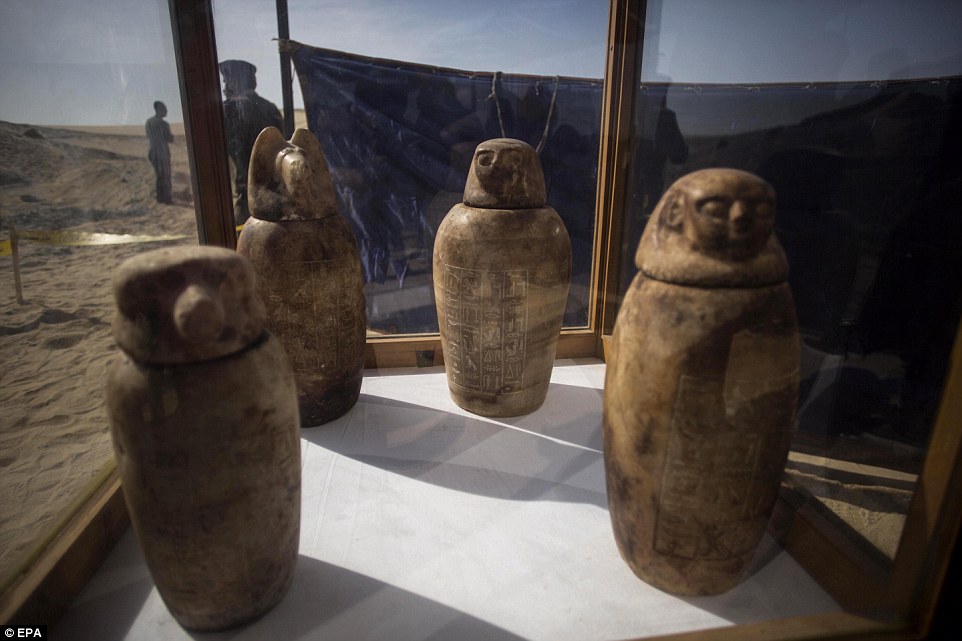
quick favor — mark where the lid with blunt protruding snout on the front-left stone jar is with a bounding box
[113,245,266,365]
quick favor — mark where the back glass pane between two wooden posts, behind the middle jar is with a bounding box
[214,0,607,335]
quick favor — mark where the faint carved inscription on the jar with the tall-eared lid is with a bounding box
[264,260,363,374]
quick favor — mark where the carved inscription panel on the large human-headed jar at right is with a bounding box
[654,375,794,559]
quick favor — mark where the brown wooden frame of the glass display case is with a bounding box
[0,0,962,641]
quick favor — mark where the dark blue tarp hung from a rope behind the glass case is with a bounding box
[283,42,962,442]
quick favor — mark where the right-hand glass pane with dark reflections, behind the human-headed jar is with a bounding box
[620,0,962,557]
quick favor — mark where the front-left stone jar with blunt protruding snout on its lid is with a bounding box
[107,246,301,630]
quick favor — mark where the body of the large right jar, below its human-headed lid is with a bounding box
[603,273,799,595]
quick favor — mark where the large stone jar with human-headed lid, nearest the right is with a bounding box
[603,169,799,595]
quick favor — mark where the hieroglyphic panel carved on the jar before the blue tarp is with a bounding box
[443,265,528,394]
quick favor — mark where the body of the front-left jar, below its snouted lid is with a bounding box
[107,332,301,630]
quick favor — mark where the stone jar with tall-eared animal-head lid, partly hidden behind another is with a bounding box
[237,127,366,427]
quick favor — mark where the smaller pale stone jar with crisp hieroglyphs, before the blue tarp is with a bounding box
[434,138,571,416]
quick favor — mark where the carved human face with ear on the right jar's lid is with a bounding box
[665,169,775,261]
